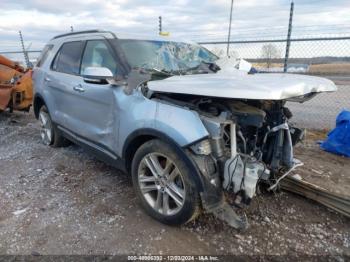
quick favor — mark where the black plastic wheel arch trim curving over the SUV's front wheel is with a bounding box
[122,128,204,192]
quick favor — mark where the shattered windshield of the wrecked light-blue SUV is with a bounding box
[118,40,218,72]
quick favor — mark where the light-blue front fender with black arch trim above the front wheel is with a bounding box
[118,92,216,199]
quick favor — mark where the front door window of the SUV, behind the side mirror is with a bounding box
[81,40,117,75]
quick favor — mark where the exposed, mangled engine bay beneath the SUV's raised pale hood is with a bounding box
[149,93,304,223]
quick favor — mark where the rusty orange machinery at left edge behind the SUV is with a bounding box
[0,55,33,111]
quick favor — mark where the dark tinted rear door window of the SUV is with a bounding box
[52,41,83,75]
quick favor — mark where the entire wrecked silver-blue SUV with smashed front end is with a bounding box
[33,30,336,228]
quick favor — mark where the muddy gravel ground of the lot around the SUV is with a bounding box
[0,113,350,256]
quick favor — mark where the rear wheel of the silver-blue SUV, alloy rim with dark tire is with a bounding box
[39,105,69,147]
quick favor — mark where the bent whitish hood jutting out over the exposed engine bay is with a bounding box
[148,70,337,100]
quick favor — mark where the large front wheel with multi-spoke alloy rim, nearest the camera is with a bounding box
[131,139,200,225]
